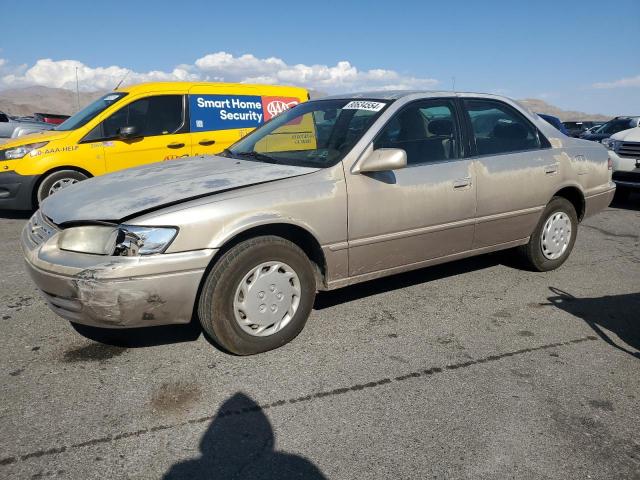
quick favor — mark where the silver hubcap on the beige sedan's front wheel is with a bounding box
[233,262,300,337]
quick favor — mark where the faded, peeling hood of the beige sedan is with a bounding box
[42,156,318,225]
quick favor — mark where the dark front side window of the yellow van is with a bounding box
[102,95,184,138]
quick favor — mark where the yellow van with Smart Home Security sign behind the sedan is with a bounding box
[0,82,309,210]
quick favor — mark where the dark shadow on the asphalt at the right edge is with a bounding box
[548,287,640,359]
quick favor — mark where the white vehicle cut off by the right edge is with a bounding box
[602,127,640,197]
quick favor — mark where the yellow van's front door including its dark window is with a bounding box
[102,95,191,172]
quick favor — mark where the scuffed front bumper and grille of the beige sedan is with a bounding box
[21,212,216,328]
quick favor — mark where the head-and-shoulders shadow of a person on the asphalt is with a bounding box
[162,393,326,480]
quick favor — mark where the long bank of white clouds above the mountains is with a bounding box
[0,52,438,92]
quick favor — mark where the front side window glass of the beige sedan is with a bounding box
[373,100,458,165]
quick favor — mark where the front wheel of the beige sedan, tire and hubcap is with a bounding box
[198,236,316,355]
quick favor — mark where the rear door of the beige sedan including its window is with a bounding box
[462,98,560,248]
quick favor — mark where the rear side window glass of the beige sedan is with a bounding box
[464,99,541,155]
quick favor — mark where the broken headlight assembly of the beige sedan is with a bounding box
[58,225,178,257]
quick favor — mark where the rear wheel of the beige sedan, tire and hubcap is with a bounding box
[518,197,578,272]
